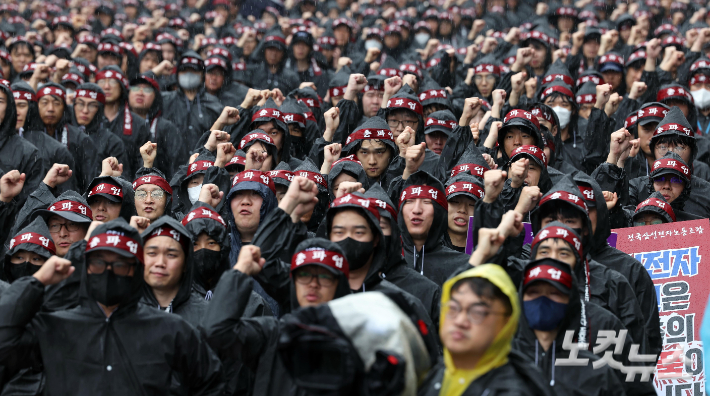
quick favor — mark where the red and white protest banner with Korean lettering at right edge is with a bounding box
[613,219,710,396]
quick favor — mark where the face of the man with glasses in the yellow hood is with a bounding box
[440,284,509,357]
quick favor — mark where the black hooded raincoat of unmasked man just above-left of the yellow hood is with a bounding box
[389,171,469,286]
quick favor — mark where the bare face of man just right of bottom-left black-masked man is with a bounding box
[143,236,185,290]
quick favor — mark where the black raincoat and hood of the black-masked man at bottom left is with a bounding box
[0,219,222,395]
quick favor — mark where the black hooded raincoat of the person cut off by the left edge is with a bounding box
[0,80,44,205]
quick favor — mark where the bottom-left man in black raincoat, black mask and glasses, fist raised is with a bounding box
[0,219,222,395]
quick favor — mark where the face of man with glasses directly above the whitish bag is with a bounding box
[293,265,338,307]
